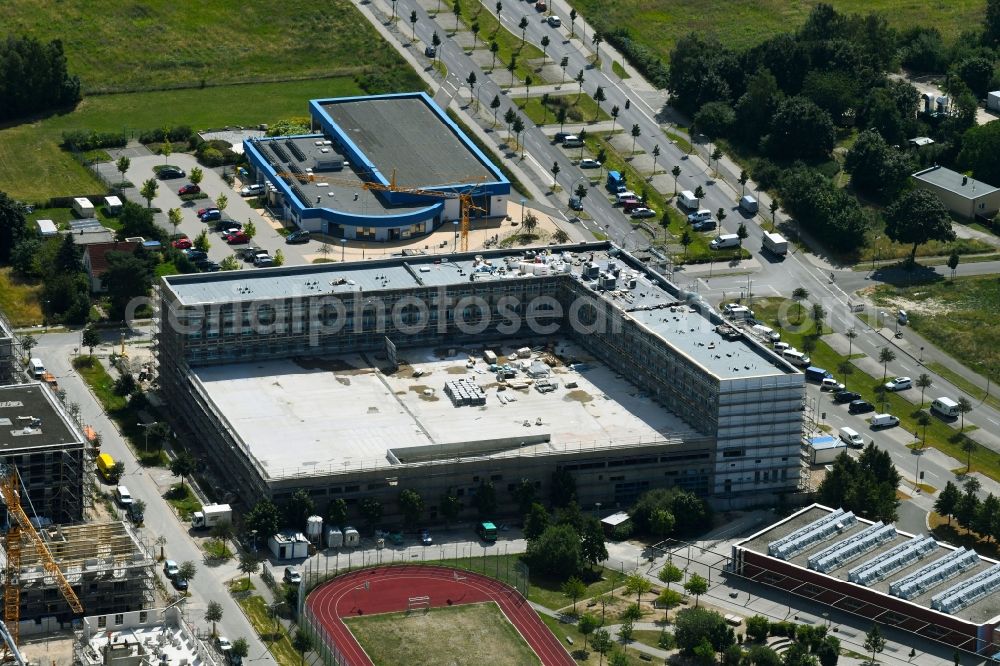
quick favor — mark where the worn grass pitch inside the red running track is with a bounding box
[345,603,541,666]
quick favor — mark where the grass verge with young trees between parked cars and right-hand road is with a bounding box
[753,298,1000,480]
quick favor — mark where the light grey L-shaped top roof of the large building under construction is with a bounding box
[164,244,803,383]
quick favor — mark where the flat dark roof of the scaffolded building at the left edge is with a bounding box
[0,383,83,455]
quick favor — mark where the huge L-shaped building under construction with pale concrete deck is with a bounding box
[156,243,804,519]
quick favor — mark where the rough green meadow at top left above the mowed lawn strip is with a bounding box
[4,0,414,94]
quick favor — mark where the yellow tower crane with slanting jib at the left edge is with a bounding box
[0,465,83,655]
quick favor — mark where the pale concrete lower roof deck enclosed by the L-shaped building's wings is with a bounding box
[192,340,700,480]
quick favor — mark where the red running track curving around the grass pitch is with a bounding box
[306,566,575,666]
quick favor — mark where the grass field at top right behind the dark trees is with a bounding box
[571,0,983,67]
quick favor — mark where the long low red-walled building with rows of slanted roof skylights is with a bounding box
[732,504,1000,655]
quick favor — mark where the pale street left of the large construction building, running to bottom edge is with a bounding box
[35,332,276,664]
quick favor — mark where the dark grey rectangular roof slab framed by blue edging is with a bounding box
[322,96,496,187]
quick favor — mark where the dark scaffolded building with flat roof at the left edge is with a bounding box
[0,383,86,524]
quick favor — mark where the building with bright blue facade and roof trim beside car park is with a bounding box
[243,92,510,242]
